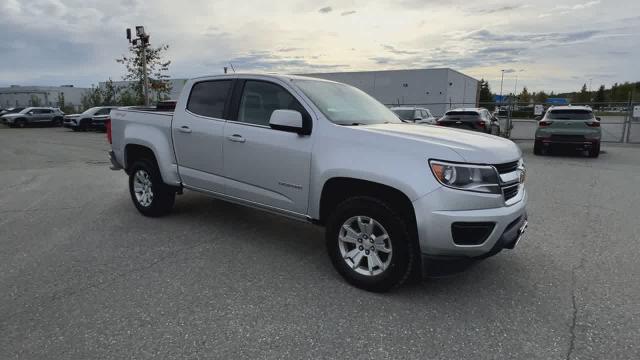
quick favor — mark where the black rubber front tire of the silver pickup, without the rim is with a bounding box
[325,196,418,292]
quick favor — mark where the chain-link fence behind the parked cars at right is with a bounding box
[387,102,640,144]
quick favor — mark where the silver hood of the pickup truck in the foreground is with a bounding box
[357,124,522,164]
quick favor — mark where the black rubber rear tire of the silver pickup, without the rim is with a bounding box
[129,159,176,217]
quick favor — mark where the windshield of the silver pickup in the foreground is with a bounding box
[295,80,402,125]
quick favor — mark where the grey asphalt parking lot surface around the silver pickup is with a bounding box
[0,127,640,359]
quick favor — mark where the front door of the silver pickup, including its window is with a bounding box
[224,80,312,216]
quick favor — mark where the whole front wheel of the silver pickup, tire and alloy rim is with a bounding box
[326,197,417,292]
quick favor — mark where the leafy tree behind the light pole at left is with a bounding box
[116,45,171,104]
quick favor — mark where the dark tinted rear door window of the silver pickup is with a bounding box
[187,80,231,119]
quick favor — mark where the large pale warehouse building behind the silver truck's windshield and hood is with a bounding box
[301,69,480,116]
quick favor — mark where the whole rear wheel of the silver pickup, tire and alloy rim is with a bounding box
[129,160,176,217]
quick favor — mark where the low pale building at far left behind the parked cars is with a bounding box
[0,85,90,110]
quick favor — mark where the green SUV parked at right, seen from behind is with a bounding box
[533,106,602,157]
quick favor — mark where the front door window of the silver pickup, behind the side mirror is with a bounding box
[238,80,306,126]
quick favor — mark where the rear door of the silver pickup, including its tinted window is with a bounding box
[172,79,234,193]
